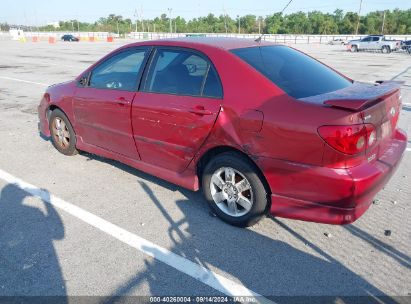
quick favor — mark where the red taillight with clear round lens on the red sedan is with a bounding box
[318,124,377,155]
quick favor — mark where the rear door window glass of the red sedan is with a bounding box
[145,49,222,97]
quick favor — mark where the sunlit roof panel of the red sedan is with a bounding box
[132,37,277,50]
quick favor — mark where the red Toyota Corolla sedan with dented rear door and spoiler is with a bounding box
[39,38,407,226]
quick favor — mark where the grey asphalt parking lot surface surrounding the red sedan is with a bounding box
[0,41,411,303]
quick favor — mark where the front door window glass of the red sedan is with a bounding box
[89,49,147,91]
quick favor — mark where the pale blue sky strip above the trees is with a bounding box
[0,0,411,25]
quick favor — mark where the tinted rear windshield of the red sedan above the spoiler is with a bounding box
[231,46,352,98]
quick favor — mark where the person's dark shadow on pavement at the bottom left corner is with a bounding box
[0,184,67,303]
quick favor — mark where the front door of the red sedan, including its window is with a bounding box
[73,48,147,159]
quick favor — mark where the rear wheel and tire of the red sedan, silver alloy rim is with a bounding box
[202,152,269,227]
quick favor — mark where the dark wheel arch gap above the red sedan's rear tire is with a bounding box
[196,146,271,210]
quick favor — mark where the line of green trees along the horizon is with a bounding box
[0,9,411,35]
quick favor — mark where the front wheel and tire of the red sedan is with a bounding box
[49,109,78,156]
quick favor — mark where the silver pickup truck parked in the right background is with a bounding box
[347,35,401,54]
